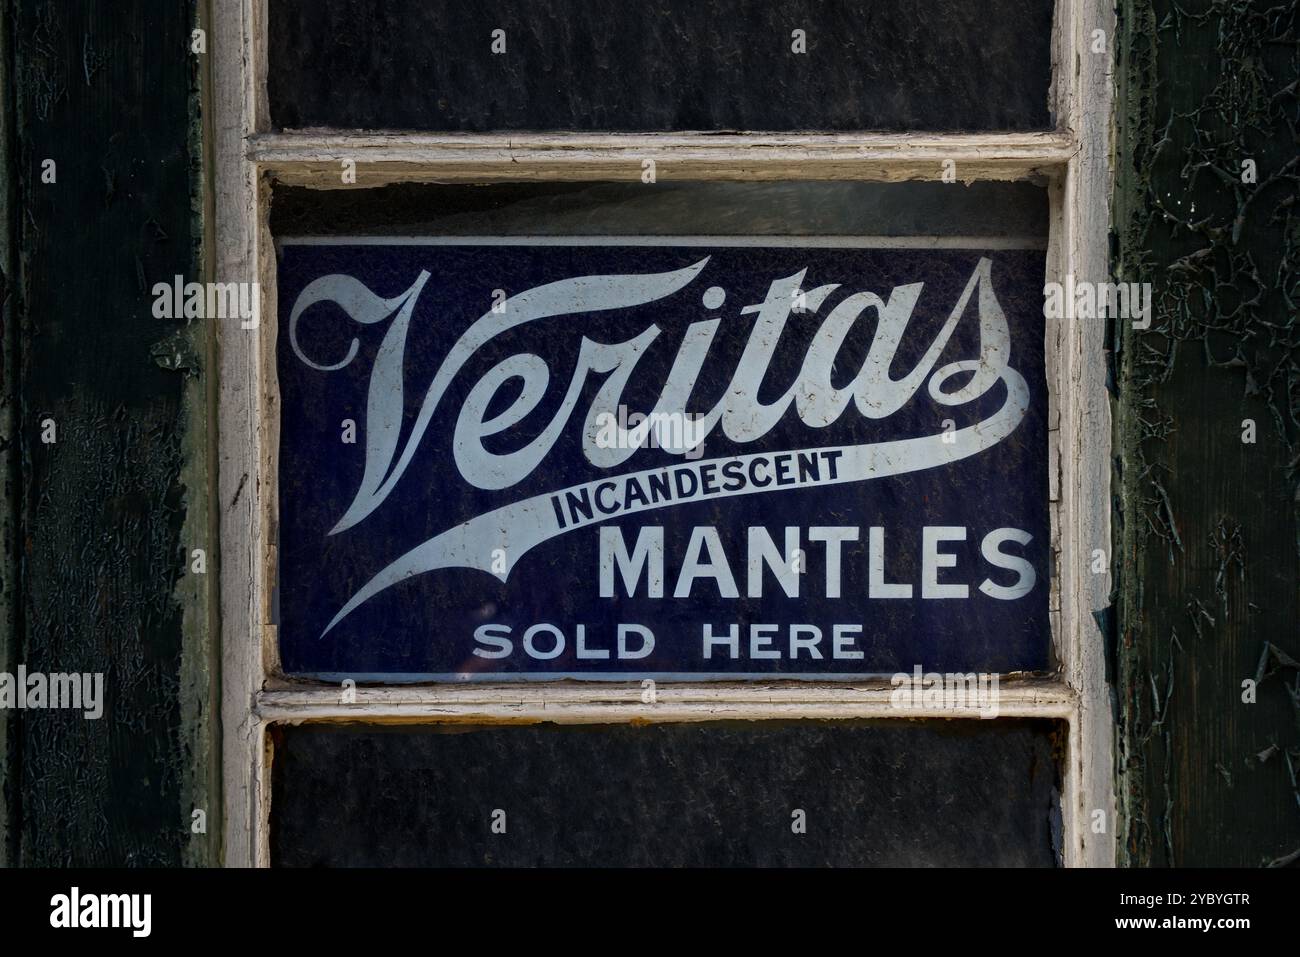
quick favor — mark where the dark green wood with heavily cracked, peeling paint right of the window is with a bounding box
[1114,0,1300,866]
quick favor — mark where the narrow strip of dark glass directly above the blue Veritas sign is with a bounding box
[270,181,1048,239]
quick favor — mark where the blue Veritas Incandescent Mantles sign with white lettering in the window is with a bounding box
[277,237,1050,681]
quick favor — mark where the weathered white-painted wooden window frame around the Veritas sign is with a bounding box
[213,0,1117,866]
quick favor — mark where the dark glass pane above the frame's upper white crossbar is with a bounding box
[268,0,1053,133]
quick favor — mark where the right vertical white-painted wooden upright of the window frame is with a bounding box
[1056,0,1117,866]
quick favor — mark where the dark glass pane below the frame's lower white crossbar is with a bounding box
[270,722,1061,867]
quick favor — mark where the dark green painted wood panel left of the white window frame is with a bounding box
[7,0,216,865]
